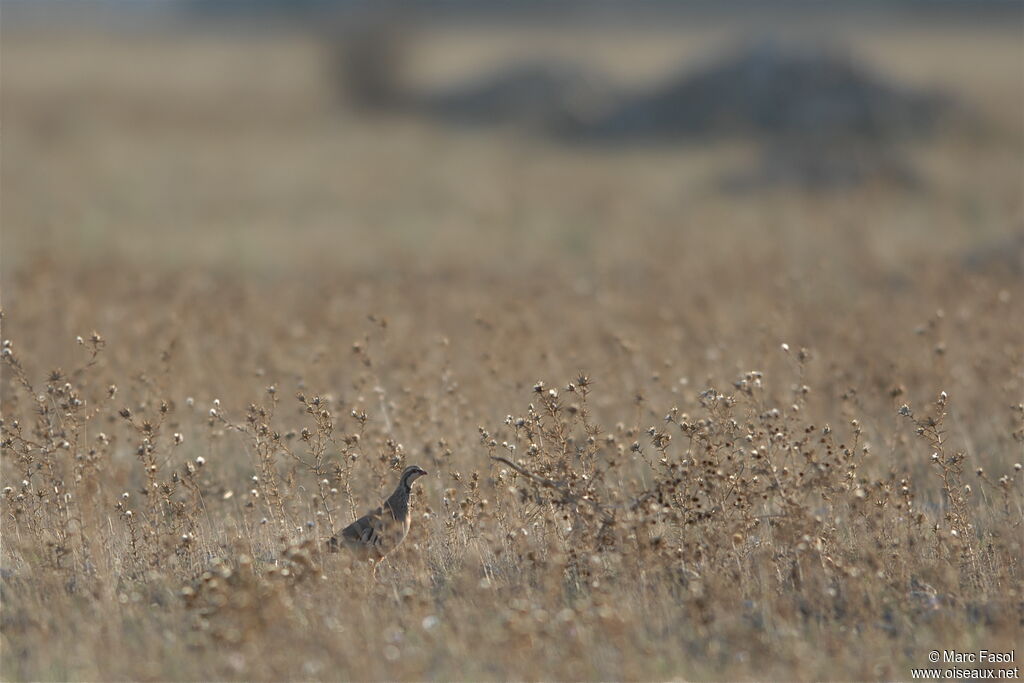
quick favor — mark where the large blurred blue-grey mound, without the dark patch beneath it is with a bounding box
[559,42,949,141]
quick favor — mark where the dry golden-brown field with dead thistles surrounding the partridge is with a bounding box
[0,21,1024,680]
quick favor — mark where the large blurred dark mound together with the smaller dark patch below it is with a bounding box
[569,42,953,191]
